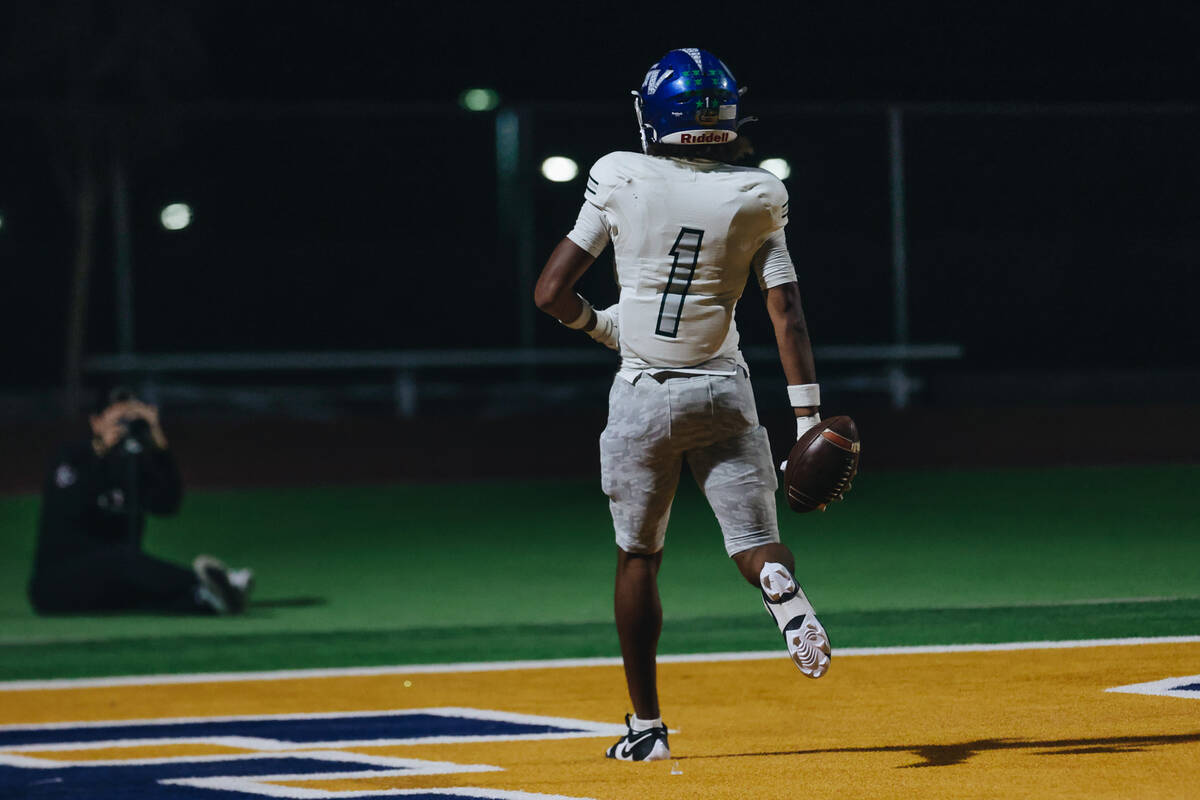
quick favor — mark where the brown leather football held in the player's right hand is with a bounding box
[784,416,860,513]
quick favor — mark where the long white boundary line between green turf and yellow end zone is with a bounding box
[0,636,1200,692]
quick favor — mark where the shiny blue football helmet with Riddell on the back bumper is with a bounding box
[634,47,745,151]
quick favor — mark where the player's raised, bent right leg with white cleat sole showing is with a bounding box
[688,374,830,678]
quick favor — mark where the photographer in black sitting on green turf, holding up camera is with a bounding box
[29,389,253,614]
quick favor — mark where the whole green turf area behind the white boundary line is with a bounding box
[0,467,1200,678]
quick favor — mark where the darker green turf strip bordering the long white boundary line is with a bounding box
[7,600,1200,679]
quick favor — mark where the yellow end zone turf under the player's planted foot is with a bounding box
[0,642,1200,800]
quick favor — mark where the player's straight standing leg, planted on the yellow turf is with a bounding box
[600,378,682,760]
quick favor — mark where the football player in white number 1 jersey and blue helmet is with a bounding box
[534,48,830,762]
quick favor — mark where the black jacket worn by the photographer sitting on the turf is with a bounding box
[34,441,184,581]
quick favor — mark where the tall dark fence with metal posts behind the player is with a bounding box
[9,101,1200,414]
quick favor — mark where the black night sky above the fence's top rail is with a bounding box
[6,0,1200,101]
